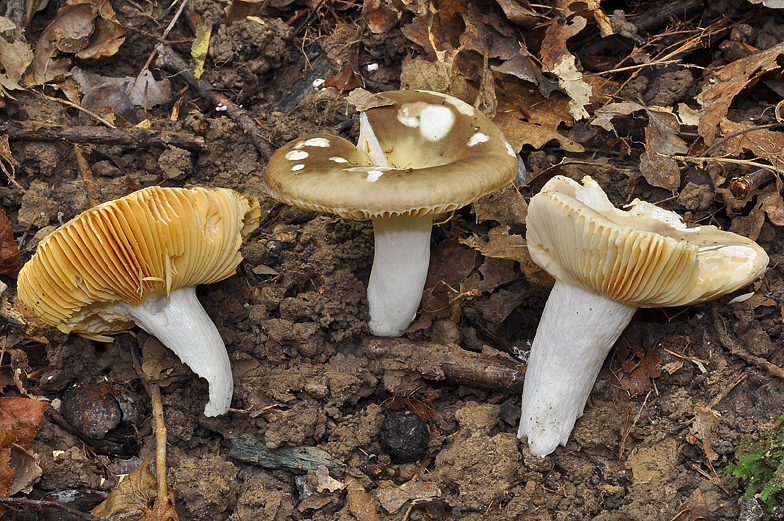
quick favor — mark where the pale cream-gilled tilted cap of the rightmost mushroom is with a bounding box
[526,176,768,307]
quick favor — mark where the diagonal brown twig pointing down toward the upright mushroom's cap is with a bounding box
[158,45,272,161]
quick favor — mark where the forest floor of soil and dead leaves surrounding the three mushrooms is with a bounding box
[0,0,784,521]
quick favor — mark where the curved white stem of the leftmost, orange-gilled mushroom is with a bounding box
[119,286,234,416]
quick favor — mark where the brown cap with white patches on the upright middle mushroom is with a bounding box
[264,91,517,219]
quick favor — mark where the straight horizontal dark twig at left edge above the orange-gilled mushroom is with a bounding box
[0,121,205,151]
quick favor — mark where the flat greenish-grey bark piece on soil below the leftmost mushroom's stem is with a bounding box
[229,438,346,478]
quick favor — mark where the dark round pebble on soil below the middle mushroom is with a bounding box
[379,412,430,463]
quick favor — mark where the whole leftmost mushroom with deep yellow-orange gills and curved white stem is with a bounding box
[17,186,261,416]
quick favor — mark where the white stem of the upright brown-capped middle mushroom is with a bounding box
[367,215,433,337]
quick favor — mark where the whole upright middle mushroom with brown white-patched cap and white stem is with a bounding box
[264,91,517,337]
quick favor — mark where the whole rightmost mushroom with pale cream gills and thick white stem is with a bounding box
[517,176,768,457]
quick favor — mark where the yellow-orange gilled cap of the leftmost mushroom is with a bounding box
[17,186,261,340]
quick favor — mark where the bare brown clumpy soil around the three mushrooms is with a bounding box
[0,0,784,521]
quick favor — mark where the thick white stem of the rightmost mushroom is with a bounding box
[517,281,637,458]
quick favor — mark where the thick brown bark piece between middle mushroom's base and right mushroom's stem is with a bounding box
[349,336,525,393]
